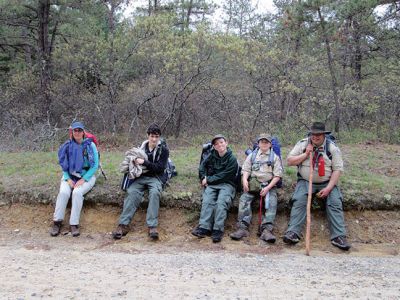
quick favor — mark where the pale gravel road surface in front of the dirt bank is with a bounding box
[0,238,400,299]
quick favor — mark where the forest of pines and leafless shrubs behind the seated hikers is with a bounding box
[0,0,400,151]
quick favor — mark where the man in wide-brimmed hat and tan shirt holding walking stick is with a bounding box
[283,122,351,250]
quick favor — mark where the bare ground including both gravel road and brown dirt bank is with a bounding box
[0,205,400,299]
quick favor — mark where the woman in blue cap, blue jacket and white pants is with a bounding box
[50,122,99,237]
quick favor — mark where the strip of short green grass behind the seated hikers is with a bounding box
[0,144,400,202]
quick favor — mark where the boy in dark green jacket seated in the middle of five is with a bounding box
[192,134,238,243]
